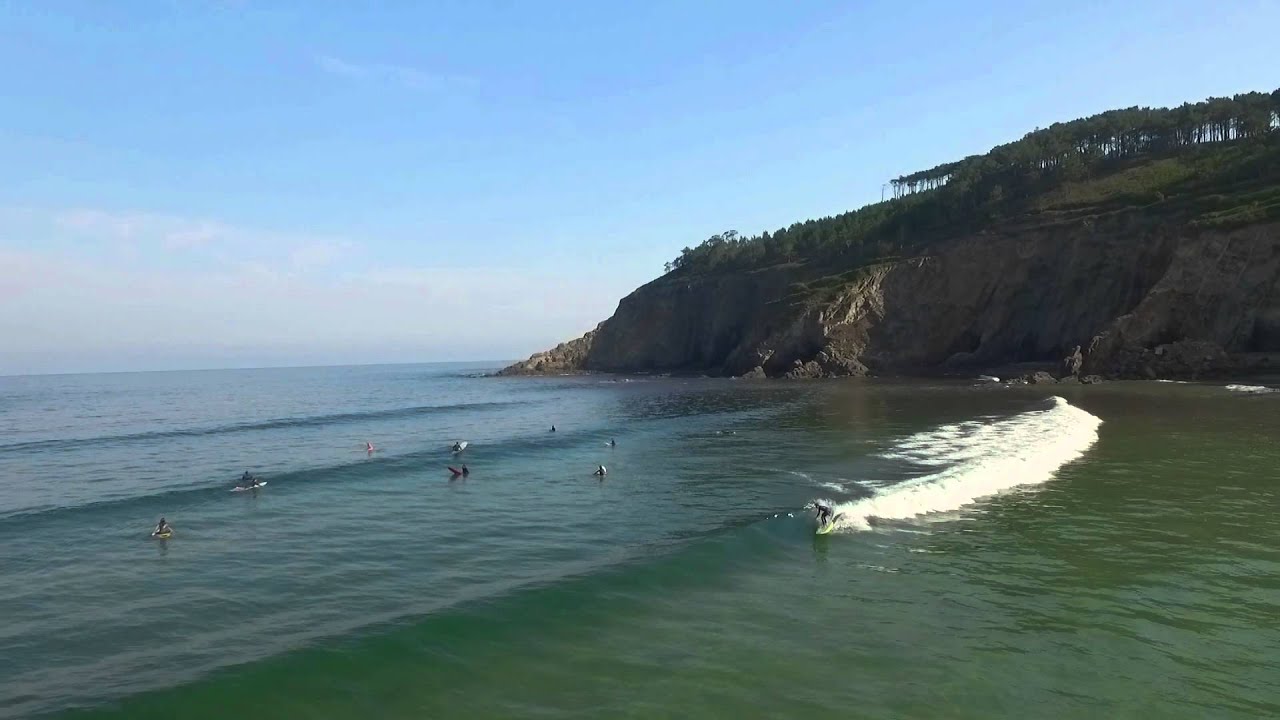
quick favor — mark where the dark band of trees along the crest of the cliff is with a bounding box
[666,88,1280,273]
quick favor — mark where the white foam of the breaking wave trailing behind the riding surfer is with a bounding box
[835,397,1102,530]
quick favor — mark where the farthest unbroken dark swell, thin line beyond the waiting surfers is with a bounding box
[0,401,527,452]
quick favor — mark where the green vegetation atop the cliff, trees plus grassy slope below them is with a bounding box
[667,84,1280,277]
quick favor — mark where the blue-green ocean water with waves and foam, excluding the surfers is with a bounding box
[0,364,1280,720]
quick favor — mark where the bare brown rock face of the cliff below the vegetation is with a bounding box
[504,215,1280,377]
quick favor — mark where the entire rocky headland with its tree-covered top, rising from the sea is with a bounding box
[503,91,1280,379]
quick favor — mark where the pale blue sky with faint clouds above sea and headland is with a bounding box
[0,0,1280,374]
